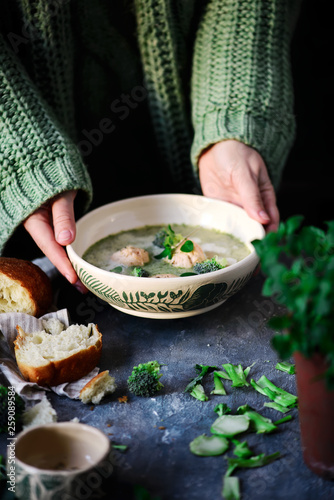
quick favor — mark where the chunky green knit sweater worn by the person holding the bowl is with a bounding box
[0,0,299,254]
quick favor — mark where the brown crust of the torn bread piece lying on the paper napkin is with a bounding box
[14,325,102,387]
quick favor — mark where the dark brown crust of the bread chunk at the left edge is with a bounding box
[0,257,53,317]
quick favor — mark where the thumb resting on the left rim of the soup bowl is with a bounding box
[52,191,76,246]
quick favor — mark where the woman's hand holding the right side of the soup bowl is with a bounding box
[199,140,279,232]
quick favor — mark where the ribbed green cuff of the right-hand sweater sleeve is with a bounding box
[191,109,295,188]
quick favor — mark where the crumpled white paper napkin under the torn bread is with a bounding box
[0,309,99,407]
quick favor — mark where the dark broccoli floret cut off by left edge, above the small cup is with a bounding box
[0,385,25,433]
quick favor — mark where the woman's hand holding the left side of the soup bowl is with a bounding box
[23,191,86,292]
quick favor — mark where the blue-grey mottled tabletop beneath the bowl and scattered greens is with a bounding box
[0,275,334,500]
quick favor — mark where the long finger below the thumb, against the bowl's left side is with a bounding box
[24,211,85,291]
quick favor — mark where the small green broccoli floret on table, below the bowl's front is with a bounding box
[128,361,163,397]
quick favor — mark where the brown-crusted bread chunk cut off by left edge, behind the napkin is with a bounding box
[0,257,52,317]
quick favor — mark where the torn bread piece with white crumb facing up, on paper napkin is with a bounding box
[14,319,102,386]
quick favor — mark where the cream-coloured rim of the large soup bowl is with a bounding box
[66,193,265,284]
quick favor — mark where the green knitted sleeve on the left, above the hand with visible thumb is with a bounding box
[0,35,92,251]
